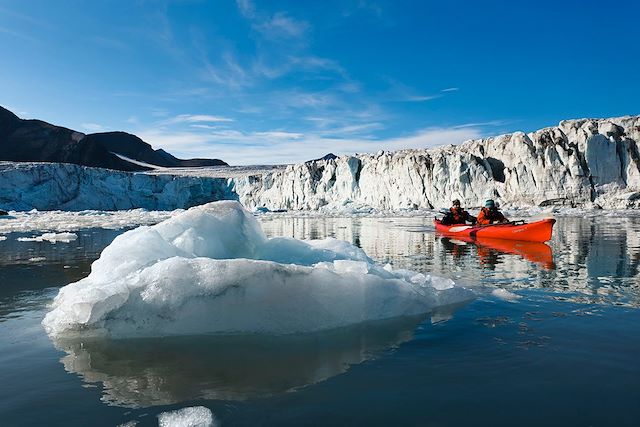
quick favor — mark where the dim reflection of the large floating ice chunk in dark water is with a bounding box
[50,314,455,407]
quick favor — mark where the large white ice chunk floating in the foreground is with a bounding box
[43,201,473,337]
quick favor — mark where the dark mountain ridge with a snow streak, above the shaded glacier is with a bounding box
[0,107,227,171]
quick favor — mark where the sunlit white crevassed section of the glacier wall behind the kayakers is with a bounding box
[235,116,640,210]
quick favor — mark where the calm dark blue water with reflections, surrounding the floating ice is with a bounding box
[0,217,640,426]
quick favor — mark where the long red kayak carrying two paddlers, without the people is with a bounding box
[433,218,556,242]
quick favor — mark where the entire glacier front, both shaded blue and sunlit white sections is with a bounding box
[0,116,640,213]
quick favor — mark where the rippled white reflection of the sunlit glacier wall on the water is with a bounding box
[262,216,640,306]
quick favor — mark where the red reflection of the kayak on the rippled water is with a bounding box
[441,236,556,270]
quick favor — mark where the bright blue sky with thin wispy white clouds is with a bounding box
[0,0,640,165]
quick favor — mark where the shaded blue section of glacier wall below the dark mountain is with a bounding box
[0,162,237,211]
